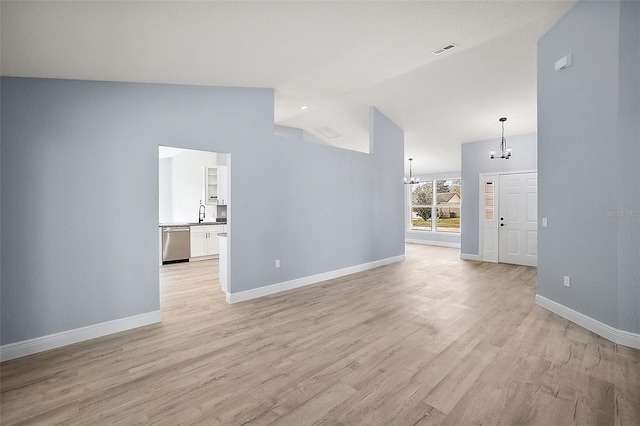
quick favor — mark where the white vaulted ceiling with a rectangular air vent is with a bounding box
[0,1,574,173]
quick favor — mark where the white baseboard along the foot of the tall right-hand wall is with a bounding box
[536,294,640,349]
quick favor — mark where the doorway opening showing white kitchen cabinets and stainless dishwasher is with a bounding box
[158,146,231,300]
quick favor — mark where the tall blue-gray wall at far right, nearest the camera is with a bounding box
[538,1,640,333]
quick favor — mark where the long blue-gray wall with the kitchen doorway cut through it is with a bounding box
[0,77,404,344]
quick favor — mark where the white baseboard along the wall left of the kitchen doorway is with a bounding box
[0,311,162,361]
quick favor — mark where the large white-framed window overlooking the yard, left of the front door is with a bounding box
[410,179,462,232]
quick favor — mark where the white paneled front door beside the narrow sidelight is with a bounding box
[498,173,538,266]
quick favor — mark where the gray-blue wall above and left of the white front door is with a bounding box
[460,132,538,255]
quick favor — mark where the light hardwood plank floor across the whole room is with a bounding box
[0,244,640,426]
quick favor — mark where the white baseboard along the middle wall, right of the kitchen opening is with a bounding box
[226,254,406,303]
